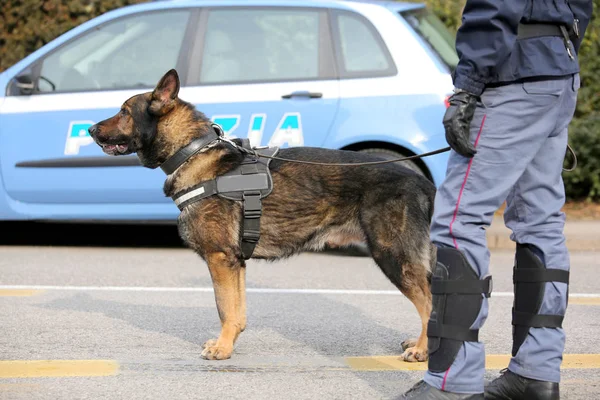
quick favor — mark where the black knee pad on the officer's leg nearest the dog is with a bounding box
[427,248,492,372]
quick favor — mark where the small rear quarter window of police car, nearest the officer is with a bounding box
[337,13,393,77]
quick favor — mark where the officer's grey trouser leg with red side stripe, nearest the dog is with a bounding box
[404,78,568,399]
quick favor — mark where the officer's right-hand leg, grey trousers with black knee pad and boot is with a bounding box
[486,76,579,399]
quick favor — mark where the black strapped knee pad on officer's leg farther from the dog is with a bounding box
[512,243,569,357]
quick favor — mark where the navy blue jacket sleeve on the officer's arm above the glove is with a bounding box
[454,0,527,95]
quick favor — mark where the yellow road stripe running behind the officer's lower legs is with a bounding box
[346,354,600,371]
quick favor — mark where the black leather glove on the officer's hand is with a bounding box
[443,91,477,158]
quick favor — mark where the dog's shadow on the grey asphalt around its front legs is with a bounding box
[37,292,420,357]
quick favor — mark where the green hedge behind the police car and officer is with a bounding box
[0,0,600,201]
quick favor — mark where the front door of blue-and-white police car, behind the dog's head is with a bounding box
[0,9,199,204]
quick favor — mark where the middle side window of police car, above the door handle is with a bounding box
[200,9,319,84]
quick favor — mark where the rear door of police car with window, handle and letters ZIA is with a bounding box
[181,6,339,147]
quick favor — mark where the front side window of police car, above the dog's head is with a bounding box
[39,10,190,92]
